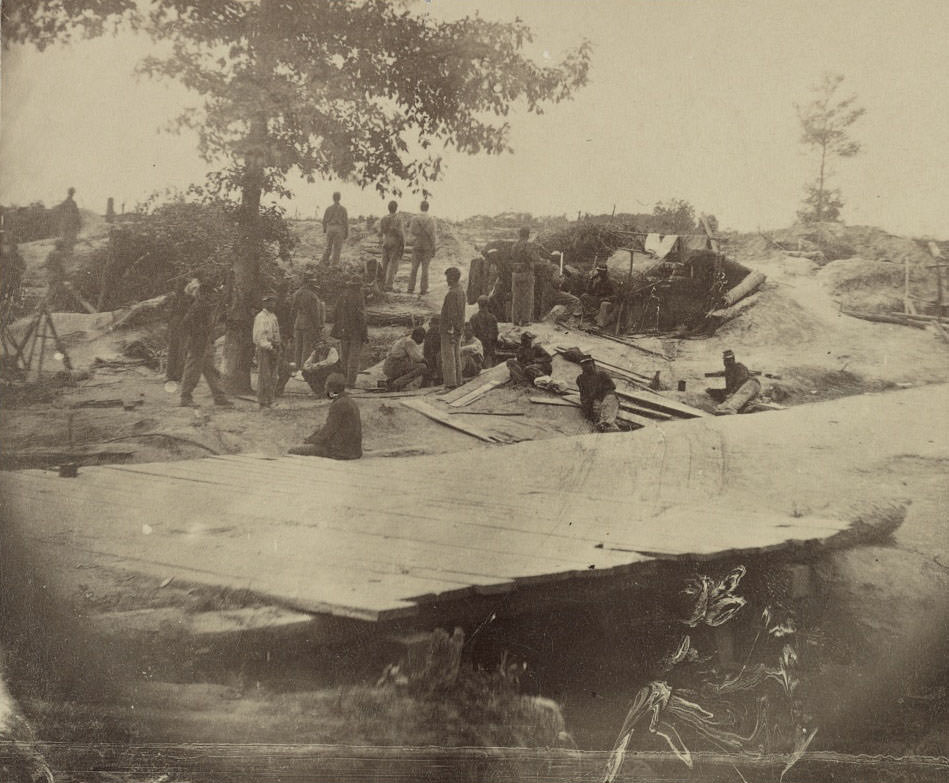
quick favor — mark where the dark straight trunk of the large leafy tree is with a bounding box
[224,116,267,394]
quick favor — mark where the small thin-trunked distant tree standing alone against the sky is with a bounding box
[794,73,866,223]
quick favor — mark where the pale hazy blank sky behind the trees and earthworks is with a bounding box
[0,0,949,238]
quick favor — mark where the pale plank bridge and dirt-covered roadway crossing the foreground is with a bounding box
[0,386,949,621]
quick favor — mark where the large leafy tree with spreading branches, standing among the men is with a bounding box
[3,0,590,389]
